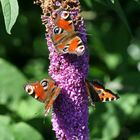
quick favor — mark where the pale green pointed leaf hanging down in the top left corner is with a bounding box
[0,0,19,34]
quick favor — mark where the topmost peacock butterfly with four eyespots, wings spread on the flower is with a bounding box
[51,10,85,56]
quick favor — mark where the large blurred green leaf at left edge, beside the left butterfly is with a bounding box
[0,58,26,110]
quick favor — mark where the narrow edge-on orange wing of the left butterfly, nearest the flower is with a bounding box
[45,87,61,116]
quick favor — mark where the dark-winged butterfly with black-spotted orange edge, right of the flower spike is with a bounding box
[85,79,120,104]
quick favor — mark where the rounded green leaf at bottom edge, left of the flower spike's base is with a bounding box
[12,122,43,140]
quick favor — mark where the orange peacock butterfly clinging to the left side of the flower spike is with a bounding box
[24,78,61,116]
